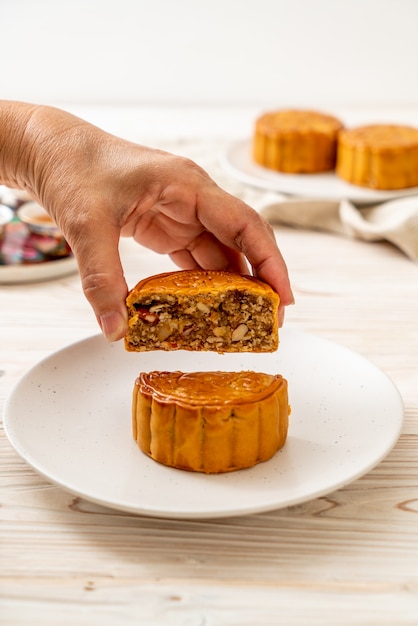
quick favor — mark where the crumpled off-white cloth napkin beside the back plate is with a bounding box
[258,193,418,262]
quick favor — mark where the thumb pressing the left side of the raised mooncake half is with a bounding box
[72,223,128,341]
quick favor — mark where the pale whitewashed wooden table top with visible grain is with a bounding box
[0,116,418,626]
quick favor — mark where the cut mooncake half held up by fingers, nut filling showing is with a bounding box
[125,270,279,353]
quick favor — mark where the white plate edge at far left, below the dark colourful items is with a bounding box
[0,255,77,285]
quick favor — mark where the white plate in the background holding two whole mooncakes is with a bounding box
[220,140,418,204]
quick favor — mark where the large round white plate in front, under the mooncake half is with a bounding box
[4,329,403,518]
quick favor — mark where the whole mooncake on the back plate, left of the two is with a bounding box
[253,109,343,174]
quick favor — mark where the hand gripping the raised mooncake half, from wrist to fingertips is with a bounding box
[0,105,293,341]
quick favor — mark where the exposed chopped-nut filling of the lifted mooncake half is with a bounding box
[126,289,277,352]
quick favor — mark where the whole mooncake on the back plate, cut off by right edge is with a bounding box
[336,124,418,190]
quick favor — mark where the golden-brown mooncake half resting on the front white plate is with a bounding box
[132,371,290,474]
